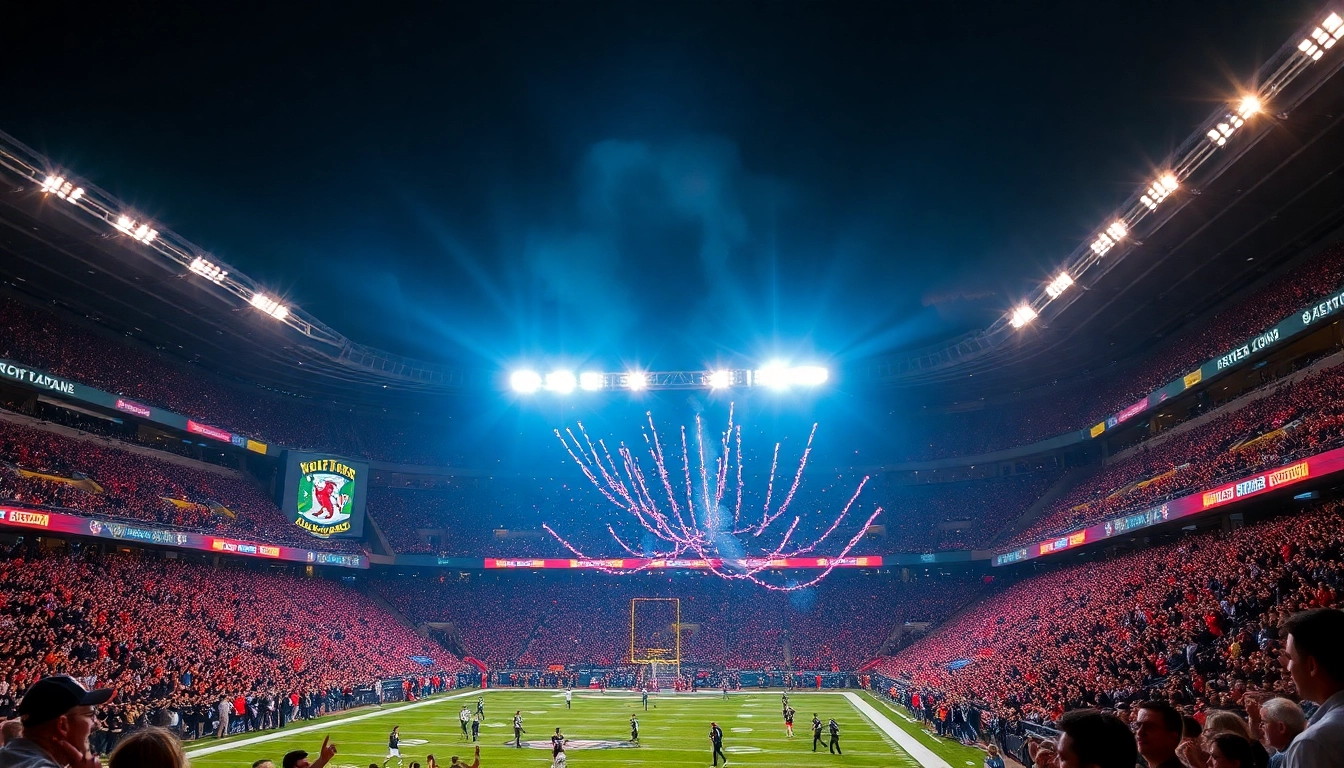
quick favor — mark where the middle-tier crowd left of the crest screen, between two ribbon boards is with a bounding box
[0,418,358,550]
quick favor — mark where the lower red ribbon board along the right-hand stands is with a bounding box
[995,448,1322,566]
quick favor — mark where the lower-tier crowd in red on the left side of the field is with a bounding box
[0,547,462,724]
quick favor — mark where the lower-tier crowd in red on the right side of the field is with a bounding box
[879,502,1344,720]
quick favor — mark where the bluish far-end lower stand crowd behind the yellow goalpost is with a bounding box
[372,572,978,671]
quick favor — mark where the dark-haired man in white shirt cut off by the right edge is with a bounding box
[1281,608,1344,768]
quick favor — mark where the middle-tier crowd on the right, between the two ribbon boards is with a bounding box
[1011,366,1344,545]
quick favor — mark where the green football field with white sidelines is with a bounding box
[188,690,982,768]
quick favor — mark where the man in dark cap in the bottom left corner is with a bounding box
[0,675,116,768]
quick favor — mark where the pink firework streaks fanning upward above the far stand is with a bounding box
[542,405,882,592]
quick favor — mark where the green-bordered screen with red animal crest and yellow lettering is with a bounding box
[280,451,370,538]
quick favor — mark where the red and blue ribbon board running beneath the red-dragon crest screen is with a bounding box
[0,506,368,568]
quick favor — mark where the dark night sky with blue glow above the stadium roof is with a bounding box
[0,0,1321,370]
